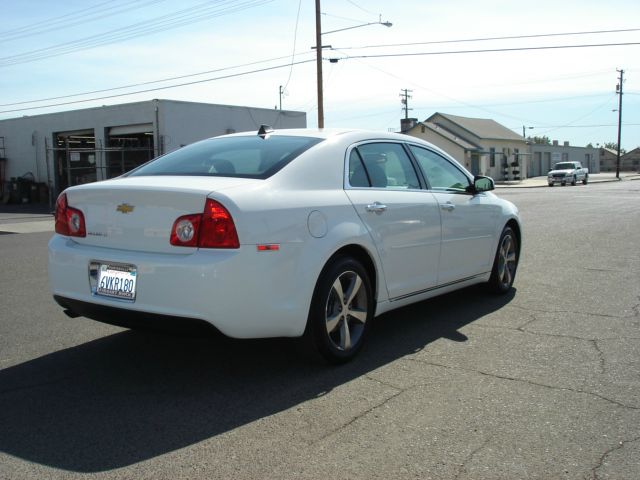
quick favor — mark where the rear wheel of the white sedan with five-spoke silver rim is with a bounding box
[304,256,375,364]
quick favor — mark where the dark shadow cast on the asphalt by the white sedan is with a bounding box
[0,287,515,472]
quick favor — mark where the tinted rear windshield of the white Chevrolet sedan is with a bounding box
[128,135,322,179]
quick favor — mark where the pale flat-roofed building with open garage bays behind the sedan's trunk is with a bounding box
[0,100,307,200]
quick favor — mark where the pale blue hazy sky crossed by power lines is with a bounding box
[0,0,640,150]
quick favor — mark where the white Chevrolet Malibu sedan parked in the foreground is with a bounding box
[49,126,522,363]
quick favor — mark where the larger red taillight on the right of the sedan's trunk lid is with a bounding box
[170,198,240,248]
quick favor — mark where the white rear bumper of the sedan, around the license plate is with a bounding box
[49,235,314,338]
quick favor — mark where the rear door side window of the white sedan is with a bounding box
[349,142,420,189]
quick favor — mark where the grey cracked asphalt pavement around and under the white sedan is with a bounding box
[0,174,640,480]
